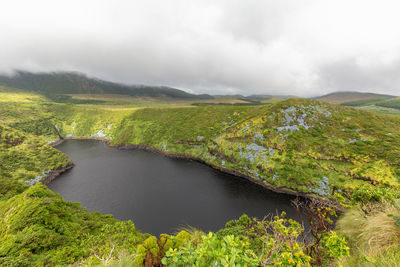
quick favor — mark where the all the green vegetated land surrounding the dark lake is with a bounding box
[0,87,400,266]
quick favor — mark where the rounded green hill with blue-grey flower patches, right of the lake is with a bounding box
[215,99,400,196]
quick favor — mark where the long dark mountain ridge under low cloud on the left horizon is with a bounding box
[0,71,213,99]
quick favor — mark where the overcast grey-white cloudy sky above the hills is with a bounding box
[0,0,400,96]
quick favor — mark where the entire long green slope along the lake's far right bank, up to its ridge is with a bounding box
[109,99,400,199]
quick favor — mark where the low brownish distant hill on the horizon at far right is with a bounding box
[314,91,396,106]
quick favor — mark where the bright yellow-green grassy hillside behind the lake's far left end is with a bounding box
[0,86,137,141]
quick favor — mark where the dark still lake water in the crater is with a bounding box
[49,140,297,234]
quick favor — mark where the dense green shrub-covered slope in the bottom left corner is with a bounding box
[0,184,146,266]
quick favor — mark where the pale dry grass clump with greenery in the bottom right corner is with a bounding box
[336,188,400,266]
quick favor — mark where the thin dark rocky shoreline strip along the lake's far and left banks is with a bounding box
[49,137,314,199]
